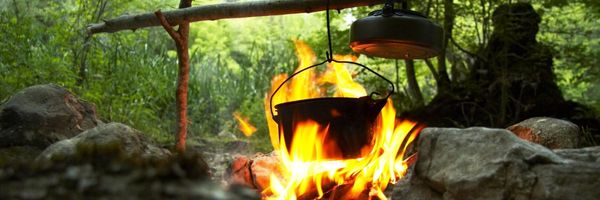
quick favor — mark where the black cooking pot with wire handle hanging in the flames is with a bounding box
[270,60,394,159]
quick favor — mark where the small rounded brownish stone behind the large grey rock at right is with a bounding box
[507,117,580,149]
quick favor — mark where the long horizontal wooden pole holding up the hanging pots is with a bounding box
[87,0,384,34]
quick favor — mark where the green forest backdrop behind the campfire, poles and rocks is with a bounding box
[0,0,600,151]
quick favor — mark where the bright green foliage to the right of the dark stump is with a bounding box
[538,3,600,109]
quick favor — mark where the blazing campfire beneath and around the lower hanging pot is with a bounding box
[234,41,423,199]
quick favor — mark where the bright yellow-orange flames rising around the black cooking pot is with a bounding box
[262,41,423,199]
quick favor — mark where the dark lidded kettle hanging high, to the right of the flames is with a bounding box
[350,1,443,59]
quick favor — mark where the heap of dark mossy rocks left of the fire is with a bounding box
[0,85,259,200]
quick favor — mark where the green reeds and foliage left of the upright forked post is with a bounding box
[0,0,176,141]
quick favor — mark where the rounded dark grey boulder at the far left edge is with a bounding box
[0,84,101,148]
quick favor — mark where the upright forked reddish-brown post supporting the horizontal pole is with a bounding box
[154,0,192,153]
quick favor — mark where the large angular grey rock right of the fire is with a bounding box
[394,128,600,200]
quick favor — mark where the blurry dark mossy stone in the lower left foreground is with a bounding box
[0,152,255,200]
